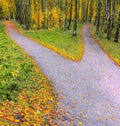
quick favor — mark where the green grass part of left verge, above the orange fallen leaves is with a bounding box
[0,23,34,100]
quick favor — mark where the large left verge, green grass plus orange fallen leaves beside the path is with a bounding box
[0,22,56,126]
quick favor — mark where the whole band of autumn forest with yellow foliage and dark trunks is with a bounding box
[0,0,120,42]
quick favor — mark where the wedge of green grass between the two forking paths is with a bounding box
[16,23,83,60]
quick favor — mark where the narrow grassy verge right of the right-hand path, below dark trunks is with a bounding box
[90,26,120,66]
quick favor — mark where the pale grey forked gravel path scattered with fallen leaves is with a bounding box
[7,22,120,126]
